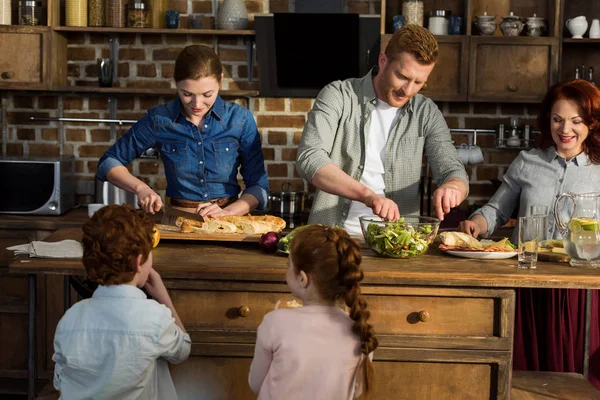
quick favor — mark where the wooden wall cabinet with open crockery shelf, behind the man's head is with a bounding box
[381,0,561,102]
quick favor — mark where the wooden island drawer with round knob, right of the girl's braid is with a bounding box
[363,287,514,350]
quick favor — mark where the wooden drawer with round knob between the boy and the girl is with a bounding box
[169,290,293,330]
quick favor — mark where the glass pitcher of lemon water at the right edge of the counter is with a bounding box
[554,192,600,268]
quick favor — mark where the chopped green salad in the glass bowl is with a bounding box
[365,218,433,258]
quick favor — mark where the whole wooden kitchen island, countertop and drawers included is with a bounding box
[9,228,600,400]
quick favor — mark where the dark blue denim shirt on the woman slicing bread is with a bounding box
[96,96,269,210]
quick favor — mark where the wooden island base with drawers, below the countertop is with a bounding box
[165,280,514,400]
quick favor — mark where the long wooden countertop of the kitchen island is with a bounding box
[10,228,600,289]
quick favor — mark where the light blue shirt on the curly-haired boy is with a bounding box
[52,285,192,400]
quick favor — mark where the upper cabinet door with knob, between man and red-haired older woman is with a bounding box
[469,37,558,102]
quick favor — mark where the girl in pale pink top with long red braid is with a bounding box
[249,225,377,400]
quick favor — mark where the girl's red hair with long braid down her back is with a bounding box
[290,225,378,393]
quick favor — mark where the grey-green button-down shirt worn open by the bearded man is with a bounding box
[296,72,469,226]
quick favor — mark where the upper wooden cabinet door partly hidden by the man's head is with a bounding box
[381,35,469,101]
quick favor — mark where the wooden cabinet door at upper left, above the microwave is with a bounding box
[0,32,43,86]
